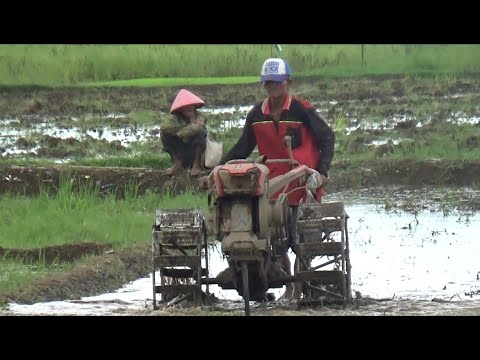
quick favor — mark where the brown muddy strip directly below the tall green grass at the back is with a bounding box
[0,75,480,118]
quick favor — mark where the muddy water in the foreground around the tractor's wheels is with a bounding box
[4,189,480,316]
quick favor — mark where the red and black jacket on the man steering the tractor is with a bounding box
[221,94,335,205]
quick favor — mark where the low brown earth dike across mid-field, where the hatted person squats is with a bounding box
[0,159,480,196]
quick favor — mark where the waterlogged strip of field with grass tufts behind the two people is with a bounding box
[0,101,480,162]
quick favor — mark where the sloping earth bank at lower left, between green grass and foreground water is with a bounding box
[0,243,152,304]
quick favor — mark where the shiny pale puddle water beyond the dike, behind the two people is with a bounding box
[0,105,480,157]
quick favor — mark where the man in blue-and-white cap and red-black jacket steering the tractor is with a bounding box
[221,58,335,299]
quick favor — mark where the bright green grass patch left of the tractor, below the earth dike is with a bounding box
[0,177,207,248]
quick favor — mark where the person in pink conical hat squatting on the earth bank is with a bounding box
[160,89,207,176]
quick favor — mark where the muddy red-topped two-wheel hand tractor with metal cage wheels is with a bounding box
[152,146,351,315]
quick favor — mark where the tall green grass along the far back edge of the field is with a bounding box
[0,44,480,86]
